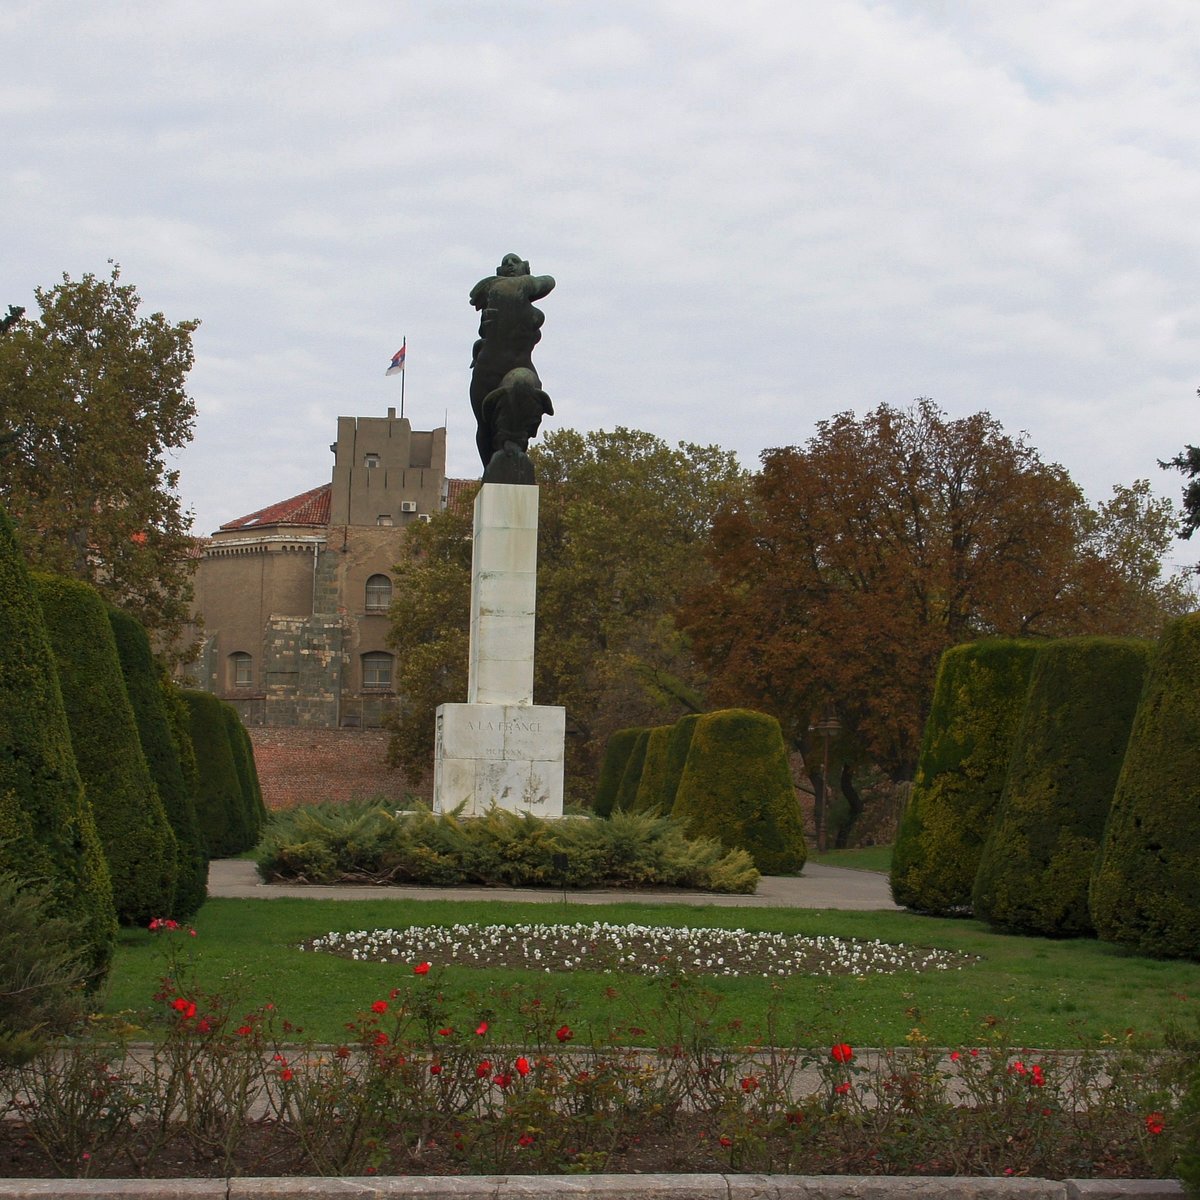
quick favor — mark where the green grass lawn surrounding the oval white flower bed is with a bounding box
[106,899,1200,1049]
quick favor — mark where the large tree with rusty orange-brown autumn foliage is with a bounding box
[682,400,1161,779]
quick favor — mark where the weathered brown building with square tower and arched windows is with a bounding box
[192,409,474,730]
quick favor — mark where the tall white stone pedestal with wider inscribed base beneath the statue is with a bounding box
[433,484,566,817]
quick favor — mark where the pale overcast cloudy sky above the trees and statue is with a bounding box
[7,0,1200,562]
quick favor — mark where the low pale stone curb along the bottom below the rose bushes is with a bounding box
[0,1175,1183,1200]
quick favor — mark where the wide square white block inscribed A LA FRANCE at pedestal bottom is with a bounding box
[433,704,566,817]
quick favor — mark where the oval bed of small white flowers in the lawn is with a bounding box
[301,922,978,979]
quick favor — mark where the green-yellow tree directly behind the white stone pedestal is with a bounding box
[391,428,745,798]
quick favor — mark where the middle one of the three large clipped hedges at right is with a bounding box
[972,637,1151,937]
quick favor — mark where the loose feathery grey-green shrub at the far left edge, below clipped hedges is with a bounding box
[0,871,89,1067]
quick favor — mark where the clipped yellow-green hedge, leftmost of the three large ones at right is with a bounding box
[892,638,1038,916]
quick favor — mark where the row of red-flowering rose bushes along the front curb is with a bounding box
[0,902,1200,1177]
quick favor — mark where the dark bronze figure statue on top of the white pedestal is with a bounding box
[470,254,554,484]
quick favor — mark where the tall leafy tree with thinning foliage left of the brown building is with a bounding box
[0,266,198,652]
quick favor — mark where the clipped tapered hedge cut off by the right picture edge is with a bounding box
[1091,612,1200,959]
